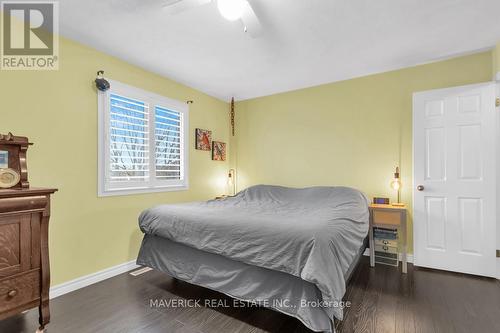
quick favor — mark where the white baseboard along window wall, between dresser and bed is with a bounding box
[49,260,139,299]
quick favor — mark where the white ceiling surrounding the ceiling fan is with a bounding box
[60,0,500,100]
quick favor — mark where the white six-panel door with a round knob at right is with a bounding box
[413,83,497,277]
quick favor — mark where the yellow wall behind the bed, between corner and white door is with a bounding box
[232,52,492,250]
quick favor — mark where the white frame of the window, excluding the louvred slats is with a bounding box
[97,80,189,197]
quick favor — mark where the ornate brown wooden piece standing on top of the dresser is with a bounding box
[0,133,31,189]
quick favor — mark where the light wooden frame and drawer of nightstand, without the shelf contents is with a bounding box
[369,204,407,273]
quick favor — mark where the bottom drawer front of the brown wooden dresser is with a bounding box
[0,270,40,313]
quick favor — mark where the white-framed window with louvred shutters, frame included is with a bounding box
[98,81,189,196]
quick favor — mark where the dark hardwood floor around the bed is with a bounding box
[0,257,500,333]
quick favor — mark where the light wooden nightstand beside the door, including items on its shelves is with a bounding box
[369,204,407,273]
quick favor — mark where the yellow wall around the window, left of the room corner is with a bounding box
[0,39,229,285]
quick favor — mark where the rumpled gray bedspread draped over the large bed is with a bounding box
[139,185,368,319]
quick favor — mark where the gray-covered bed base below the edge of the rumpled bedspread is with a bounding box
[137,235,365,332]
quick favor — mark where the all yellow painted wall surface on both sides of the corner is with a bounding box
[0,27,500,285]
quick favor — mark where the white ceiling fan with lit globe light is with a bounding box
[163,0,262,38]
